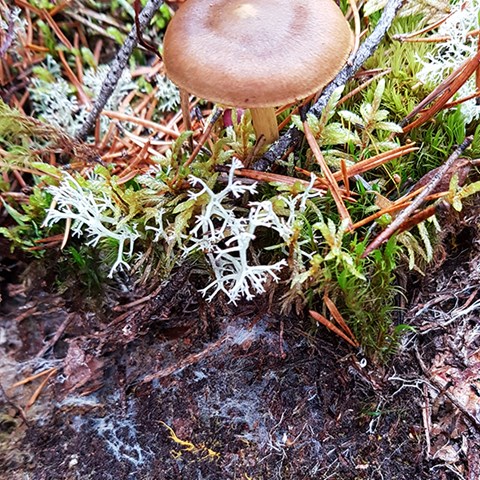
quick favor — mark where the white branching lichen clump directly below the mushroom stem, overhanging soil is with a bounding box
[185,160,317,303]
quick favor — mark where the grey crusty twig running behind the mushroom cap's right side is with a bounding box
[253,0,404,171]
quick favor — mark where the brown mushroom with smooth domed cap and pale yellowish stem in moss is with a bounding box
[163,0,353,143]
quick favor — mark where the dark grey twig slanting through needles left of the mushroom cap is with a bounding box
[76,0,163,140]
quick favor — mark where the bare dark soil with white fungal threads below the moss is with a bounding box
[0,214,480,480]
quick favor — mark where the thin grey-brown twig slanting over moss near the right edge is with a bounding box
[362,136,473,258]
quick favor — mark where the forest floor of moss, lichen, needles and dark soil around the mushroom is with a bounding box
[0,0,480,480]
